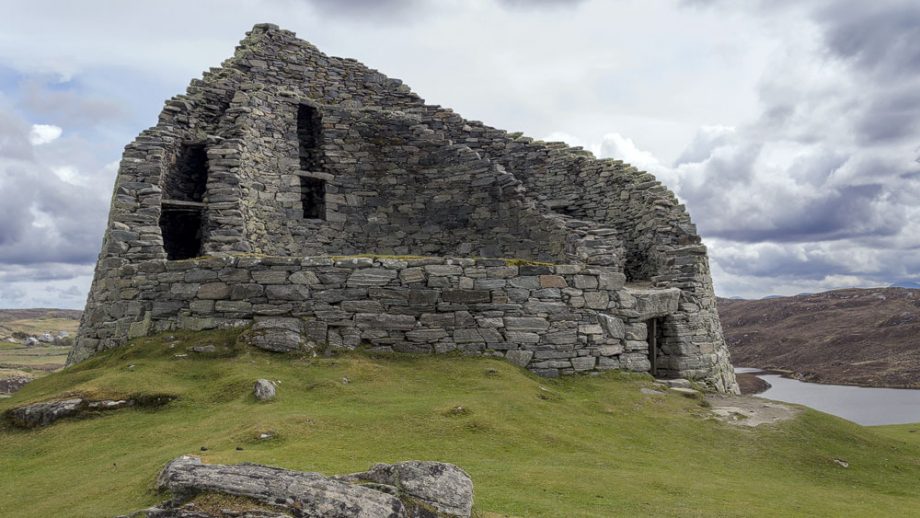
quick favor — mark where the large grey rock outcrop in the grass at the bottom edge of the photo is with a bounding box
[133,456,473,518]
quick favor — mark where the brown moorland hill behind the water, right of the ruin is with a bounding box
[718,288,920,388]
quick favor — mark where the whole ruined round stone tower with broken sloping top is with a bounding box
[69,24,737,392]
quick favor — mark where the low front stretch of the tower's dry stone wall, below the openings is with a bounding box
[77,257,679,376]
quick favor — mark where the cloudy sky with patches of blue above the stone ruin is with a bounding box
[0,0,920,308]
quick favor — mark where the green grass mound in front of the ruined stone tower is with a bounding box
[0,331,920,517]
